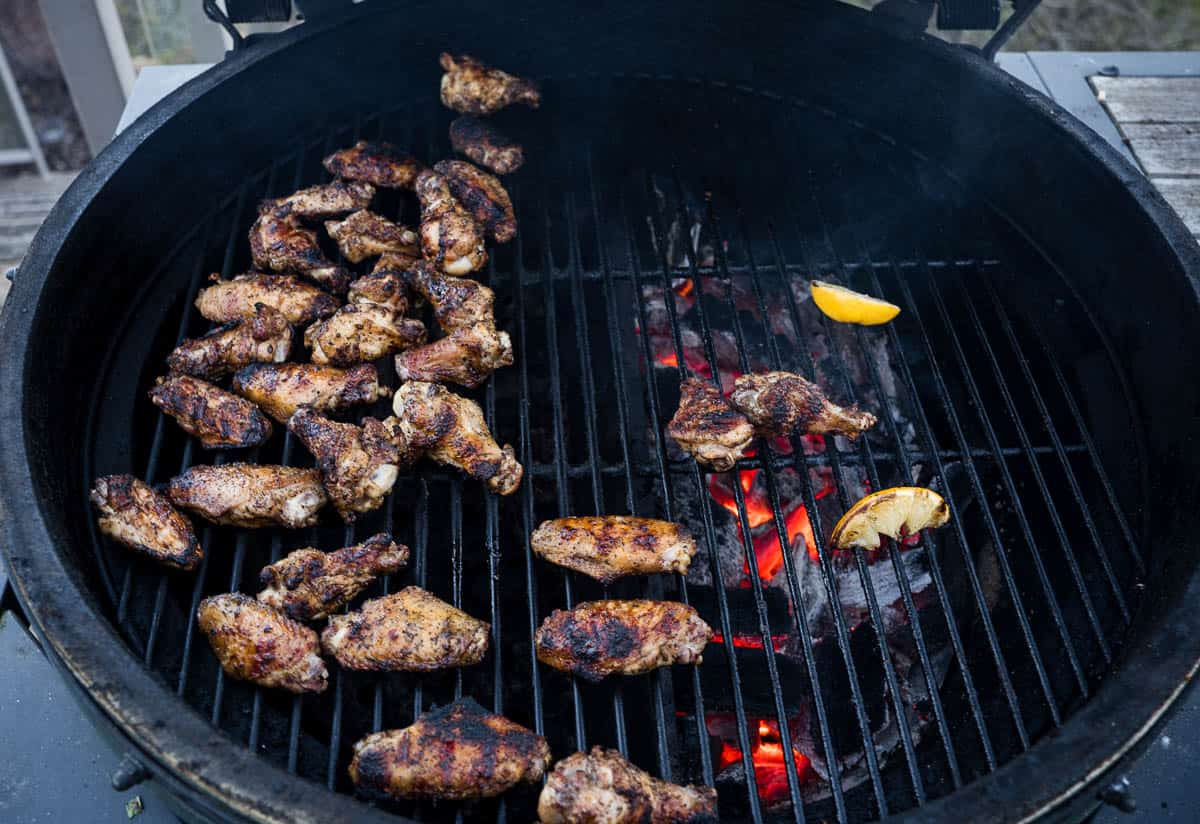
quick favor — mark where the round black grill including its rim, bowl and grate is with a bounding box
[0,5,1200,820]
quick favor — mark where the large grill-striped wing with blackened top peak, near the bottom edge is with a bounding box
[350,698,550,800]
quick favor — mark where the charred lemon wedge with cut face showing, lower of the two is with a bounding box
[829,487,950,549]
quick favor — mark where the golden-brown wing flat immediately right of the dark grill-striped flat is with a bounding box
[232,363,391,423]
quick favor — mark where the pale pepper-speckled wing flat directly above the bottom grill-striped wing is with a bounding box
[320,587,491,673]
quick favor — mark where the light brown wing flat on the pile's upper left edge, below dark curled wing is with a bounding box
[196,272,341,325]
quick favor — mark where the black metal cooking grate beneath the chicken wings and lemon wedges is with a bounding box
[88,78,1144,820]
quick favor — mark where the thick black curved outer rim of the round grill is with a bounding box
[0,6,1200,822]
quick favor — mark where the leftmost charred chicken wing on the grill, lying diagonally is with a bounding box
[89,475,204,570]
